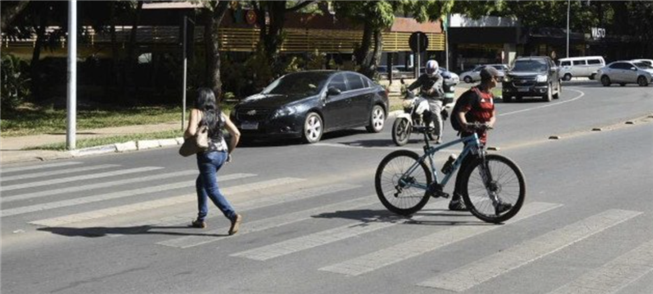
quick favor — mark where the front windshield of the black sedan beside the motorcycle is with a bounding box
[261,72,330,96]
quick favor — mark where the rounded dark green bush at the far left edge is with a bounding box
[0,54,30,112]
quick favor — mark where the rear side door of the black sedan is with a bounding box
[345,73,372,126]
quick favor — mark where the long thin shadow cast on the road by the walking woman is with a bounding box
[37,226,229,238]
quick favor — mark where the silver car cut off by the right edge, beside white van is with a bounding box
[597,60,653,87]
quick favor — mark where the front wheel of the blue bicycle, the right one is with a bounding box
[460,154,526,223]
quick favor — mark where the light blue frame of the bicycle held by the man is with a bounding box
[399,133,484,190]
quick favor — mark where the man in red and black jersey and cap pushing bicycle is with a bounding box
[449,66,512,212]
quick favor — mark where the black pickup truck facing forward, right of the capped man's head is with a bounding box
[502,56,562,102]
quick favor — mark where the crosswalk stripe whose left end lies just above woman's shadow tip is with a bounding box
[30,178,304,227]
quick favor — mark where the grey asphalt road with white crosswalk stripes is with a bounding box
[0,82,653,293]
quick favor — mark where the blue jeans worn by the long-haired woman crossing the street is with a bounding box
[195,151,236,221]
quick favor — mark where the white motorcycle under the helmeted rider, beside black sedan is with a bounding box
[392,75,457,146]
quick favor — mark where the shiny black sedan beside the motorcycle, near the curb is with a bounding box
[231,71,389,143]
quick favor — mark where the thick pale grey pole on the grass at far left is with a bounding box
[66,0,77,150]
